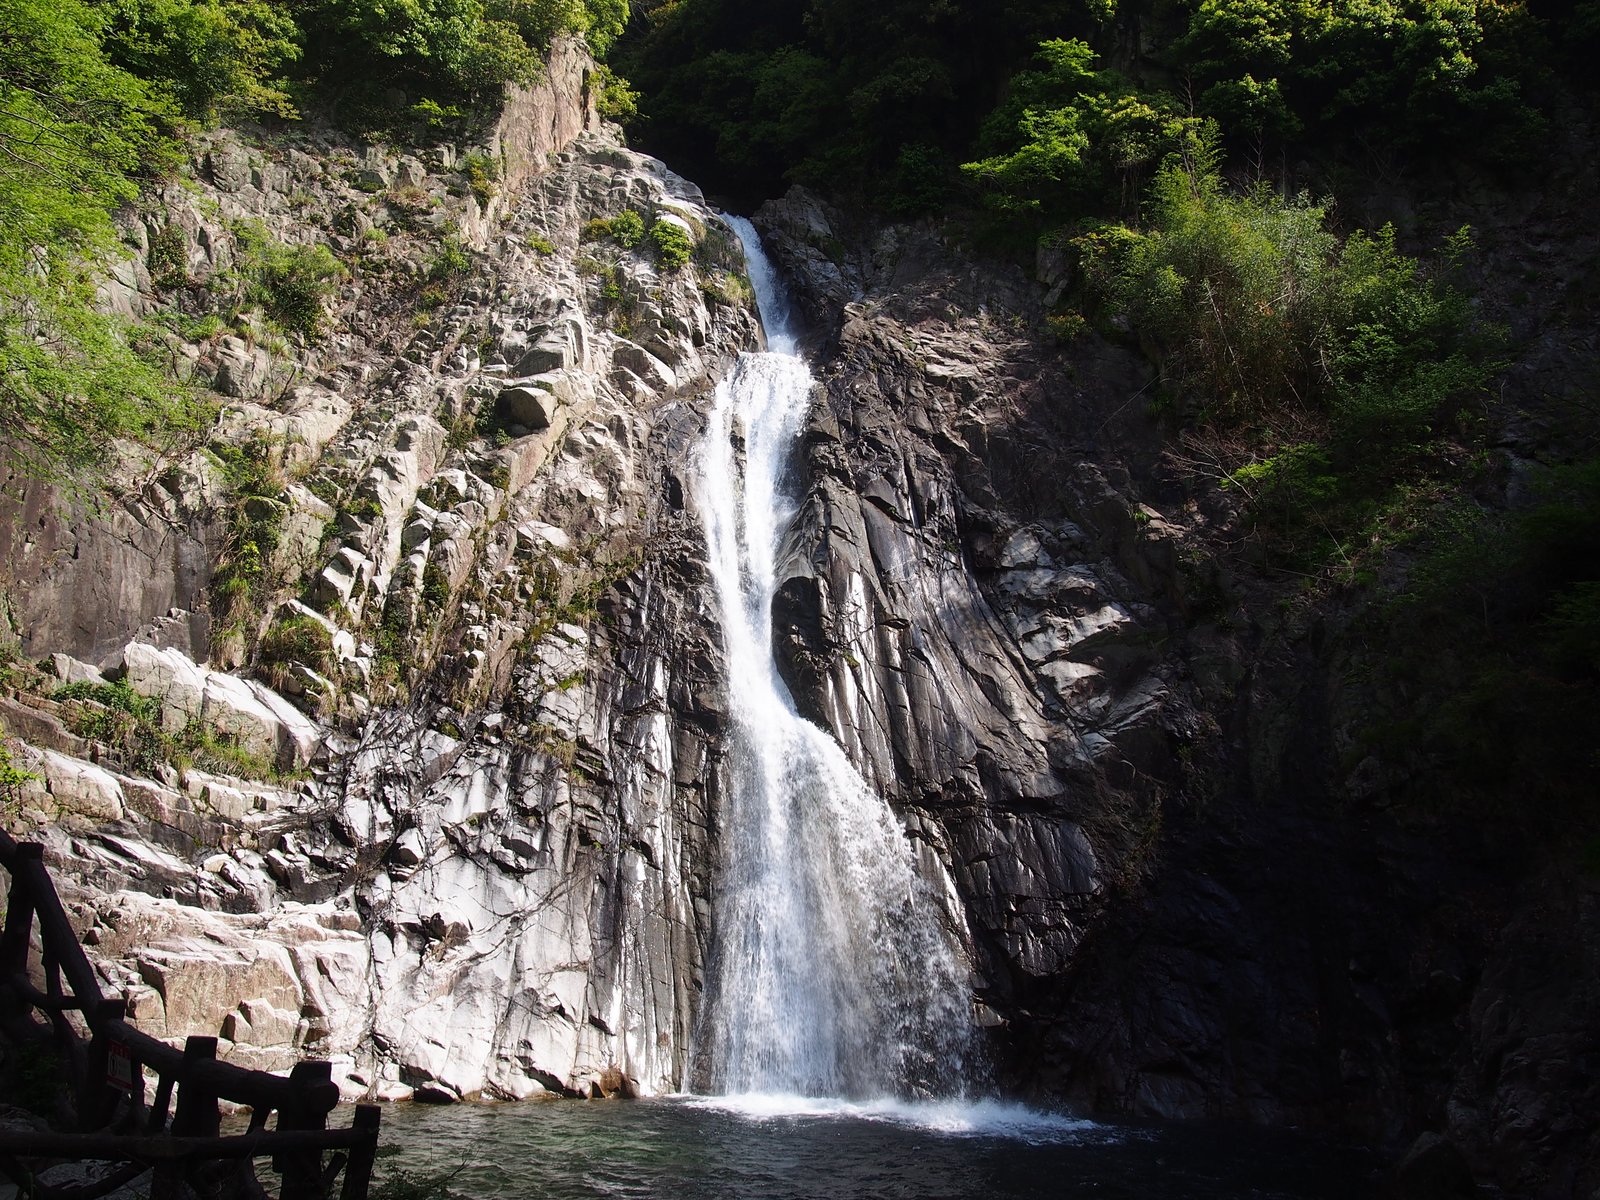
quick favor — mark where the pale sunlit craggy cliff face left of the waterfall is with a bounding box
[5,48,758,1098]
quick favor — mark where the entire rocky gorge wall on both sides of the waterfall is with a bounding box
[0,40,1595,1194]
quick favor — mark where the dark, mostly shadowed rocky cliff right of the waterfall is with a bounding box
[760,192,1600,1197]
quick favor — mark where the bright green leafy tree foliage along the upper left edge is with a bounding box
[0,0,208,475]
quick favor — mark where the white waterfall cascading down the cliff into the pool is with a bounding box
[698,218,971,1098]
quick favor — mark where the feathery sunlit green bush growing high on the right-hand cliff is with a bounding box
[1107,150,1490,445]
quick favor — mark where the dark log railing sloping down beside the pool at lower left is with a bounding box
[0,830,379,1200]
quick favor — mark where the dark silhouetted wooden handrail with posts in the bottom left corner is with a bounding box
[0,829,381,1200]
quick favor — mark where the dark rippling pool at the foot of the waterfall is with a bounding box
[368,1096,1378,1200]
